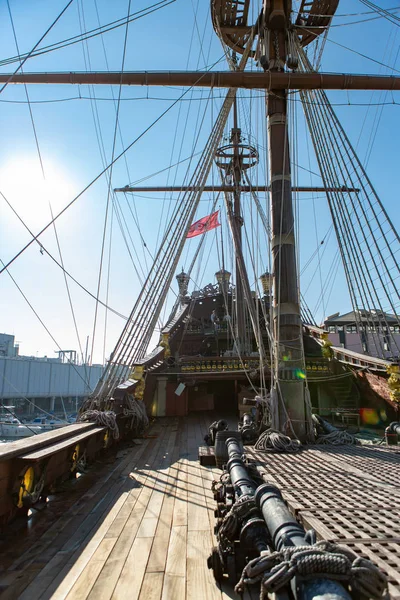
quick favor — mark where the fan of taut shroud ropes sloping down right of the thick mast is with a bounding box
[299,43,400,358]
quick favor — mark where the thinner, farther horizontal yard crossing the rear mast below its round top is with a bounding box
[114,185,360,193]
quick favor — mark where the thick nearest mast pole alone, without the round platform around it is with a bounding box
[262,0,312,441]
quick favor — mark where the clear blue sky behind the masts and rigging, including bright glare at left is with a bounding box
[0,0,400,361]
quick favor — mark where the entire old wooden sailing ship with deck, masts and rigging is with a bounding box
[0,0,400,600]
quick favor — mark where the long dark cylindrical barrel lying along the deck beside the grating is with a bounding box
[208,438,351,600]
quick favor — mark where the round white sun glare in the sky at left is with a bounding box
[0,156,74,231]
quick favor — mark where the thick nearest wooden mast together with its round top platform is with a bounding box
[211,0,338,441]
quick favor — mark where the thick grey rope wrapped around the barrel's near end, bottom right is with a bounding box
[235,541,388,600]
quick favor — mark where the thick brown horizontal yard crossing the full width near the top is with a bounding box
[0,71,400,90]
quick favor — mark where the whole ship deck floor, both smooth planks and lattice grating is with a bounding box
[0,412,400,600]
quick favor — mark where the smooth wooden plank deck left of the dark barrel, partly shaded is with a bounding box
[0,414,256,600]
